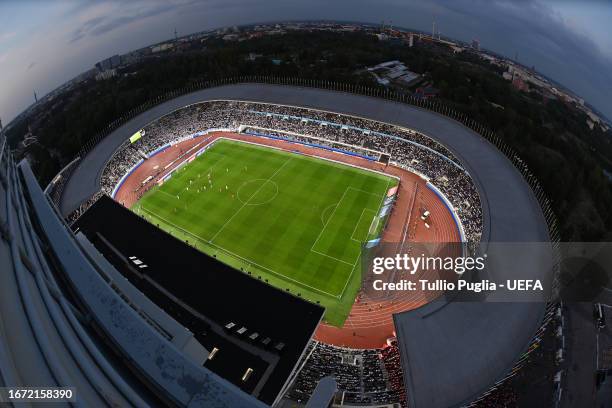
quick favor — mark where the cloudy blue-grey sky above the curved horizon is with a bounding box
[0,0,612,124]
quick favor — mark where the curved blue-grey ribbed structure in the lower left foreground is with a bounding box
[0,137,264,407]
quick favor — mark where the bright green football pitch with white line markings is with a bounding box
[132,139,397,326]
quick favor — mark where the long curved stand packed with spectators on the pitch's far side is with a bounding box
[95,101,482,243]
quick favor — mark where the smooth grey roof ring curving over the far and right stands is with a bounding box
[61,84,549,408]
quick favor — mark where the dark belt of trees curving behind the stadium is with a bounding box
[7,31,612,241]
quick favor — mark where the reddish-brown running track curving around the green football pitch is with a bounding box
[114,132,461,349]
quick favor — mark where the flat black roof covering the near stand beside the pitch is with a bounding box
[73,196,324,404]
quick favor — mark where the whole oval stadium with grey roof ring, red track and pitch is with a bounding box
[0,83,553,407]
